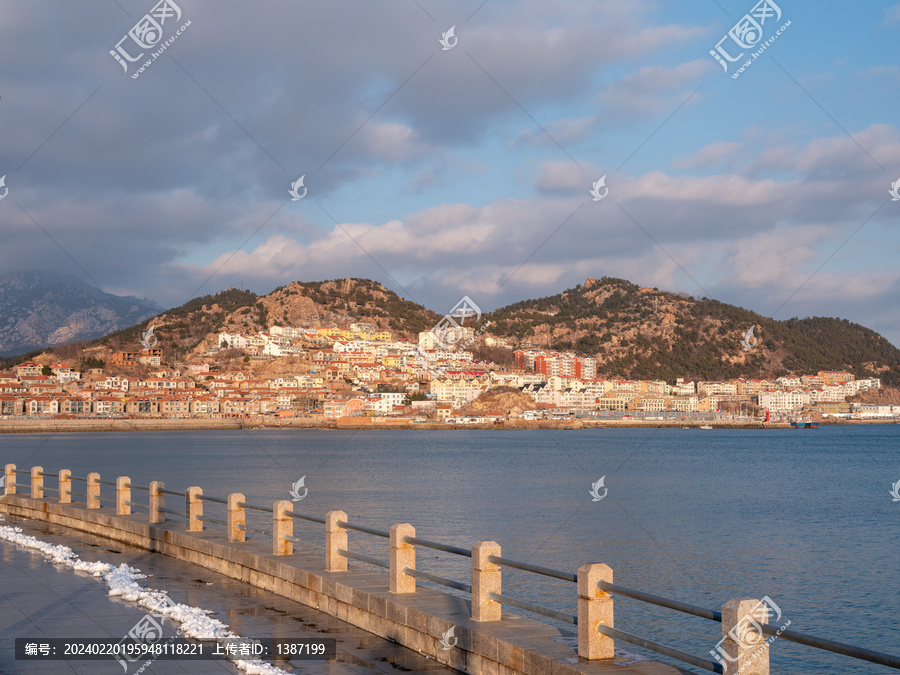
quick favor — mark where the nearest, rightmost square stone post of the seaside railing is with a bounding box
[710,598,769,675]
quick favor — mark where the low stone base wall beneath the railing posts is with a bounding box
[0,494,687,675]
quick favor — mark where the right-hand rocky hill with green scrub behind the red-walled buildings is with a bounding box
[487,277,900,384]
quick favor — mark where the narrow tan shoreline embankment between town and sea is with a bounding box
[0,418,900,434]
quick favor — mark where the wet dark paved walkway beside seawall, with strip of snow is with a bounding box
[0,515,459,675]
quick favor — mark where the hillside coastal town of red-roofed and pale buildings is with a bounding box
[0,323,884,424]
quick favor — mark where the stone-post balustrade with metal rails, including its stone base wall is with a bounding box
[7,464,900,675]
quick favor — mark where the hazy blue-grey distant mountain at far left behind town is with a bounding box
[0,272,162,356]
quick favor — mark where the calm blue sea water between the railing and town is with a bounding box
[0,425,900,674]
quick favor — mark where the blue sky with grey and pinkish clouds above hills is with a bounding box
[0,0,900,345]
